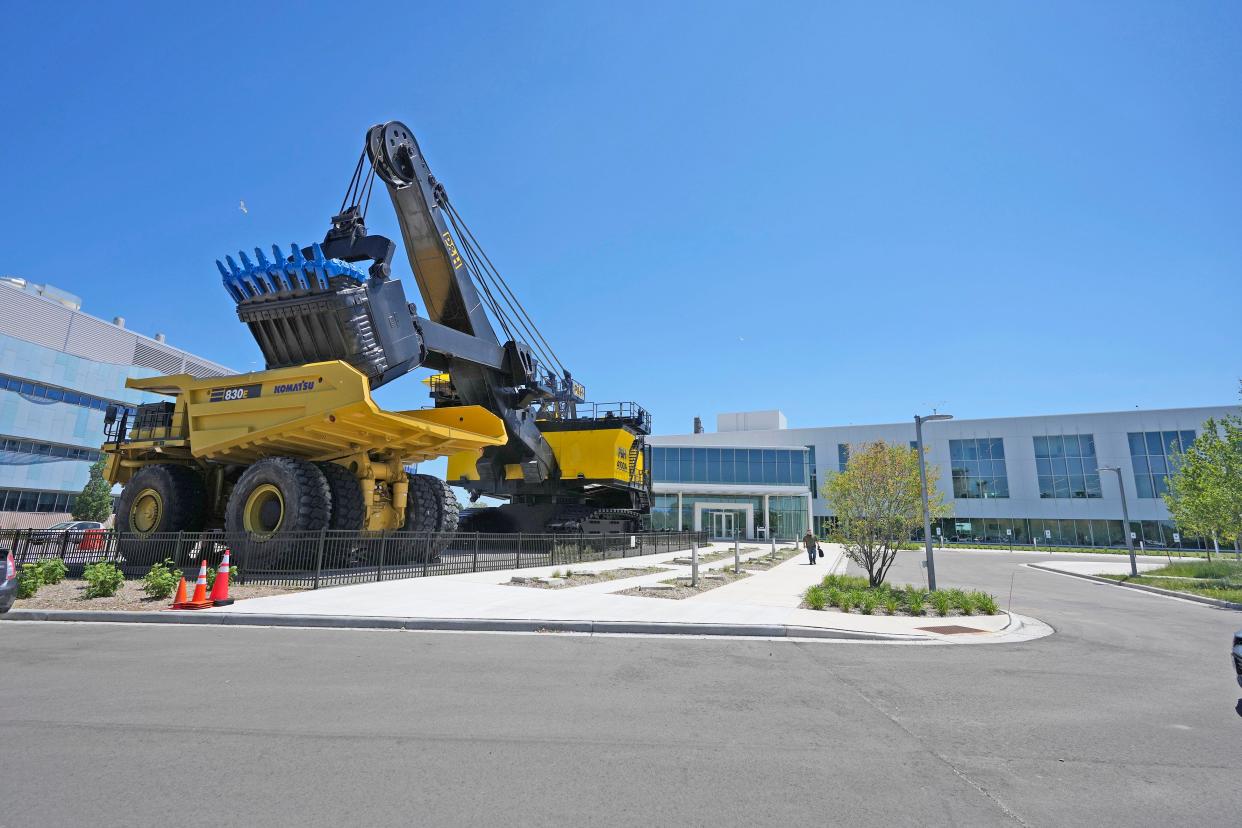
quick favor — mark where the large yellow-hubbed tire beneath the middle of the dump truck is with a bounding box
[225,457,332,572]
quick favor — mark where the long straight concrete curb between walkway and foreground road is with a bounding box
[0,610,938,642]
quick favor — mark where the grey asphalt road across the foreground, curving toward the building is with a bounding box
[0,552,1242,828]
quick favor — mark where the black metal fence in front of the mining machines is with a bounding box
[0,529,707,590]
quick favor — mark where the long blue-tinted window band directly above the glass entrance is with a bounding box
[651,446,811,485]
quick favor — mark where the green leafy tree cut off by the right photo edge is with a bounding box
[1164,417,1242,557]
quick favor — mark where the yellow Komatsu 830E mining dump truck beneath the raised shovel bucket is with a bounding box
[104,360,507,561]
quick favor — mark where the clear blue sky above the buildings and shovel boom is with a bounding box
[0,1,1242,433]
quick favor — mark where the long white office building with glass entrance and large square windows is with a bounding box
[650,406,1242,547]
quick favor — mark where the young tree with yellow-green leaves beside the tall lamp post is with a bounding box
[823,442,945,586]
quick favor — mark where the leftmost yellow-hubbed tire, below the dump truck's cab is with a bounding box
[117,463,207,566]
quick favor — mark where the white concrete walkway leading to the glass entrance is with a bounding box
[175,544,1051,642]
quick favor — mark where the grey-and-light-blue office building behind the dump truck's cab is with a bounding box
[0,278,232,528]
